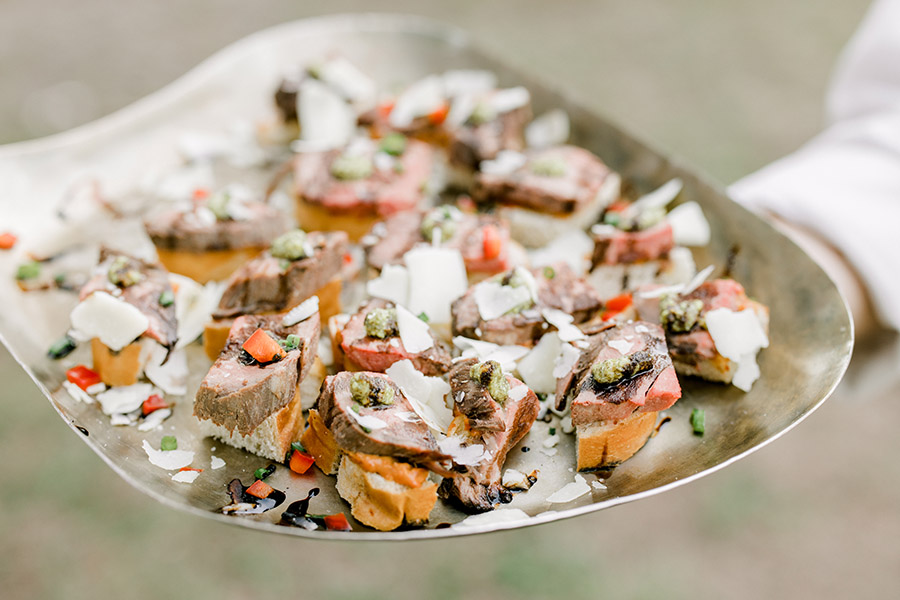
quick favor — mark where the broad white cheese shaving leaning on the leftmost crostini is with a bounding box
[71,291,150,351]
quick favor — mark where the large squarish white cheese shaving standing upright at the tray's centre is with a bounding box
[403,246,469,324]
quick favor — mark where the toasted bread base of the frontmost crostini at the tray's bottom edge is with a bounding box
[337,455,437,531]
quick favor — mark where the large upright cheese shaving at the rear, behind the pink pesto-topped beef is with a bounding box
[297,78,356,148]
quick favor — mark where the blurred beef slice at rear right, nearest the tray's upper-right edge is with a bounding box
[472,146,612,215]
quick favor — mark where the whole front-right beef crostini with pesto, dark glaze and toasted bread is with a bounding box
[556,321,681,471]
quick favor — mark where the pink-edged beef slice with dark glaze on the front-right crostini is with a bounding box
[556,321,681,426]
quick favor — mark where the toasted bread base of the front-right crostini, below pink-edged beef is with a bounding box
[575,411,658,471]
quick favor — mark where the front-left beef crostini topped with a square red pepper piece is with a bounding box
[194,313,321,462]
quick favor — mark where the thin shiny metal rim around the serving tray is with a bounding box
[0,12,856,541]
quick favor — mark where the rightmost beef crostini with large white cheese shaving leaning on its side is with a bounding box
[638,279,769,391]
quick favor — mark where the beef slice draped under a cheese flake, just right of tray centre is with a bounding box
[451,264,602,346]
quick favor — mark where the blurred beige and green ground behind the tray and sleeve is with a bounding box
[0,0,900,600]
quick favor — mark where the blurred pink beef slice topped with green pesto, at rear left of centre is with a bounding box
[293,140,434,217]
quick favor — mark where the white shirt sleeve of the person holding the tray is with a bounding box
[729,0,900,330]
